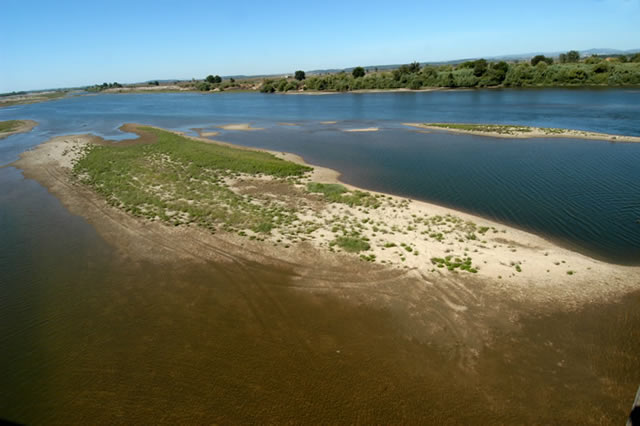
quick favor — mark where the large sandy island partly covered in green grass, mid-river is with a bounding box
[11,125,638,310]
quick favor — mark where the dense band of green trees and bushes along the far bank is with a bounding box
[260,50,640,93]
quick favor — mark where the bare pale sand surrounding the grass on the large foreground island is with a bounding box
[12,124,640,308]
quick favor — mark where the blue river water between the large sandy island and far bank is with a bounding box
[0,90,640,264]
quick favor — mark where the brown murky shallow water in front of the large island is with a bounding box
[0,171,640,424]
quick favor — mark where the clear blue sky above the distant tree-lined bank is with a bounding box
[0,0,640,93]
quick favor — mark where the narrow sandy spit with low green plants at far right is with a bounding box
[402,123,640,142]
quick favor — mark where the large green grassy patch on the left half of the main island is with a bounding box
[74,128,310,233]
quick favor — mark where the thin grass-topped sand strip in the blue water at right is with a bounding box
[404,123,640,142]
